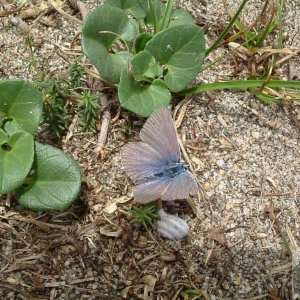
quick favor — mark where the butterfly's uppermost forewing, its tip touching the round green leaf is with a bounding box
[140,107,180,164]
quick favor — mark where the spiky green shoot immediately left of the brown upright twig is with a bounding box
[77,91,100,132]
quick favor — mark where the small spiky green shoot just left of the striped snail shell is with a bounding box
[130,204,159,229]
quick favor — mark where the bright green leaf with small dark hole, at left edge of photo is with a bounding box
[0,130,34,194]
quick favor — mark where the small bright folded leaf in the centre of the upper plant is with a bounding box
[131,51,162,81]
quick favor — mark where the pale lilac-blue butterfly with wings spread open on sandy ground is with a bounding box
[121,107,198,203]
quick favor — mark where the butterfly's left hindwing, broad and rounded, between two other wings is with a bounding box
[121,142,164,182]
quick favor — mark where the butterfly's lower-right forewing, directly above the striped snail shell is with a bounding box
[161,171,198,200]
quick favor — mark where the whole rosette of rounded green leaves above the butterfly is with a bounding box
[82,0,205,117]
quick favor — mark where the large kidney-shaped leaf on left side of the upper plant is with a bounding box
[82,5,138,83]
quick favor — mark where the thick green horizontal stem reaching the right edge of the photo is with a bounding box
[177,80,300,95]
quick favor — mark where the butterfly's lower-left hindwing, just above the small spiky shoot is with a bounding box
[133,177,172,203]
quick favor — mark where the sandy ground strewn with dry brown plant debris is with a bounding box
[0,0,300,299]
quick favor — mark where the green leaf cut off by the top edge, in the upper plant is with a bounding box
[105,0,148,19]
